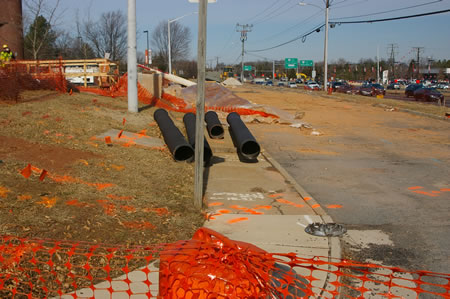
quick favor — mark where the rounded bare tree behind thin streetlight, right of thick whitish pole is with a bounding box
[152,21,191,64]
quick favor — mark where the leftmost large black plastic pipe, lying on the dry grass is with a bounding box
[153,109,194,162]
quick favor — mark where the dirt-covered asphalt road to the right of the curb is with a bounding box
[249,97,450,273]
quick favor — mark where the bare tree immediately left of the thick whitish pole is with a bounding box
[82,10,127,61]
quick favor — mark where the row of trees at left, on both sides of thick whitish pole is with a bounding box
[23,0,192,76]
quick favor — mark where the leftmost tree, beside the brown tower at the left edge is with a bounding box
[24,0,60,59]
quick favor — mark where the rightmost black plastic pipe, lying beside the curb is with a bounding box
[227,112,261,160]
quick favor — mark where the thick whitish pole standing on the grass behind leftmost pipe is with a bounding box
[127,0,138,112]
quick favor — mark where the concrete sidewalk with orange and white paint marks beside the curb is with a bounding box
[204,134,341,296]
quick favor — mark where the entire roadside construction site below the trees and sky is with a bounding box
[0,0,450,299]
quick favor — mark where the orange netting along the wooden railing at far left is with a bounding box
[0,60,67,100]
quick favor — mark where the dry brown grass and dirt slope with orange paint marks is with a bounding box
[0,91,203,245]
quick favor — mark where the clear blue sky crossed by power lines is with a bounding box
[50,0,450,63]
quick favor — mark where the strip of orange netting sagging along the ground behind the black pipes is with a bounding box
[79,74,279,118]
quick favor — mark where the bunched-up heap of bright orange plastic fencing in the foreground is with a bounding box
[159,228,274,299]
